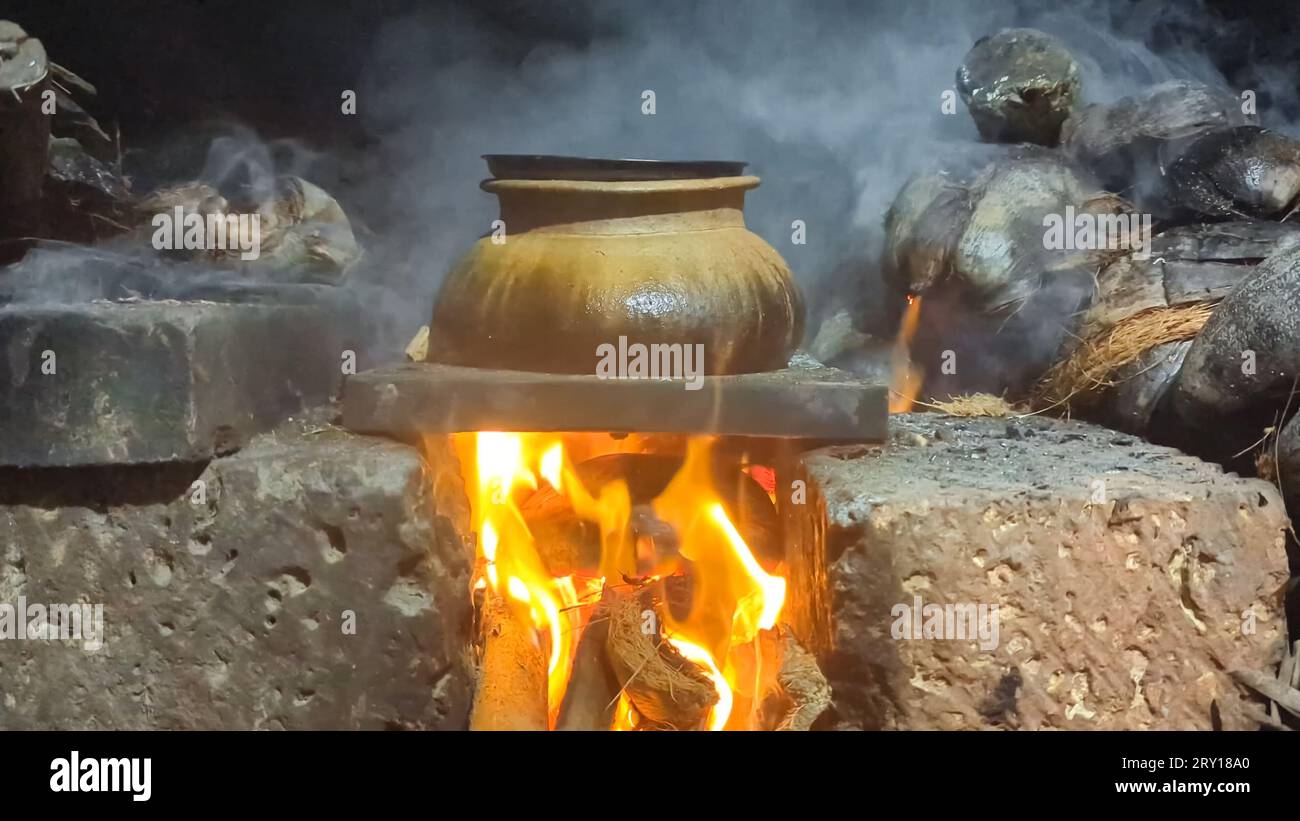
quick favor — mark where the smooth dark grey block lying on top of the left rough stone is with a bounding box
[0,286,358,466]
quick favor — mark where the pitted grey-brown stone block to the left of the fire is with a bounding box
[0,420,471,729]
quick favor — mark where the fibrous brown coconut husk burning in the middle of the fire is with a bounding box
[606,595,718,730]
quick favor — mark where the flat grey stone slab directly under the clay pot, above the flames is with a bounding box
[342,355,889,442]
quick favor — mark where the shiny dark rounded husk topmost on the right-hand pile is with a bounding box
[957,29,1079,145]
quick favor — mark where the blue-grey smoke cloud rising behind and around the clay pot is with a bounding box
[338,0,1268,350]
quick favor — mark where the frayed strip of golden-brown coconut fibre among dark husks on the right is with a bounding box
[1034,303,1214,408]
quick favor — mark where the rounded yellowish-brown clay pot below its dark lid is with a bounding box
[429,163,803,374]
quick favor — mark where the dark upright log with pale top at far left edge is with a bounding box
[0,19,49,256]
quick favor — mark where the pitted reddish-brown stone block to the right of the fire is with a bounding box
[787,414,1287,729]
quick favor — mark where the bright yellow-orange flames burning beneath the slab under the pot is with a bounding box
[452,433,787,730]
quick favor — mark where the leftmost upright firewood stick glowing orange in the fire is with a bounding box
[469,596,547,730]
